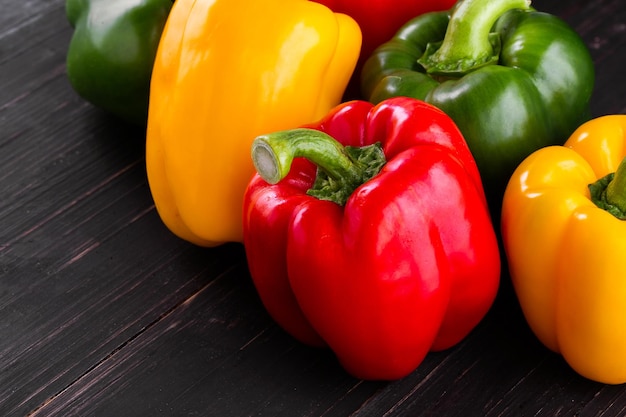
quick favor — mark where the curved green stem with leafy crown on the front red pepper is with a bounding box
[252,128,386,205]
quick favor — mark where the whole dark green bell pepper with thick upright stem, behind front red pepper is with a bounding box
[361,0,594,205]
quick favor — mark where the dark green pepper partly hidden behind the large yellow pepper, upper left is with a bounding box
[65,0,172,126]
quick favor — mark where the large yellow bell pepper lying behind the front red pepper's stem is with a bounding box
[146,0,361,246]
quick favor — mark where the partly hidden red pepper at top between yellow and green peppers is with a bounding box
[315,0,456,98]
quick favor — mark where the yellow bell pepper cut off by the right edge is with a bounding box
[502,115,626,384]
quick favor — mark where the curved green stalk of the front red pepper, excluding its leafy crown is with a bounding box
[252,128,360,184]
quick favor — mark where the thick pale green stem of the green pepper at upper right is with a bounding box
[418,0,530,77]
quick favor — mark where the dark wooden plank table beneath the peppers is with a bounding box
[0,0,626,417]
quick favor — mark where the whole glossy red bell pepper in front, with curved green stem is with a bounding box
[243,97,500,380]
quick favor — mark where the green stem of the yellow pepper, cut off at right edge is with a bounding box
[589,158,626,220]
